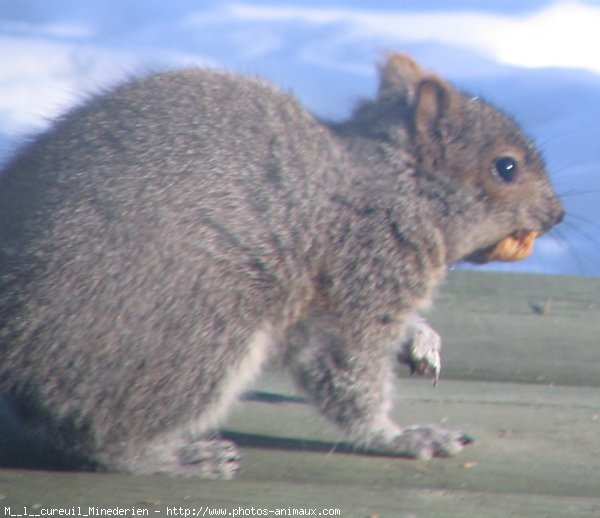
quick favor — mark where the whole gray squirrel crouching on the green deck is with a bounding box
[0,54,563,478]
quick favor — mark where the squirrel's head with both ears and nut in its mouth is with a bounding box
[378,54,564,262]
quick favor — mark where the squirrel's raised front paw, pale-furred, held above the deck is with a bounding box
[397,320,442,386]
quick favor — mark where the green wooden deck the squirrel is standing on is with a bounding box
[0,272,600,518]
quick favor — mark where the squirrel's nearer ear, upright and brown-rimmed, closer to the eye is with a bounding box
[412,76,458,161]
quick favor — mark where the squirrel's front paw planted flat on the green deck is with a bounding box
[390,426,473,460]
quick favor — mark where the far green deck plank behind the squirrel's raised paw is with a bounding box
[428,271,600,387]
